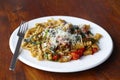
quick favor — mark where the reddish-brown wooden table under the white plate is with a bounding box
[0,0,120,80]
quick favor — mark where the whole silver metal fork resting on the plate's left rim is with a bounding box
[9,21,28,71]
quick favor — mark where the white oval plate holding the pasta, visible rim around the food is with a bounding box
[9,16,113,72]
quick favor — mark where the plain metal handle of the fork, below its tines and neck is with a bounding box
[9,37,23,71]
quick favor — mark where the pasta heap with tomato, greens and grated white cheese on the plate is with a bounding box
[22,19,102,62]
